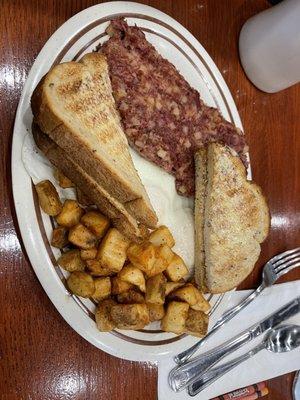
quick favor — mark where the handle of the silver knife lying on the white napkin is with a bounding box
[169,330,255,392]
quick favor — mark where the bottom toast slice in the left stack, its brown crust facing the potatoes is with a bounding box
[32,124,147,242]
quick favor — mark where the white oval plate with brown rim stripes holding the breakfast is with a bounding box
[12,2,246,361]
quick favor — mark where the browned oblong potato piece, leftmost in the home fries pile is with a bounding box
[35,180,62,217]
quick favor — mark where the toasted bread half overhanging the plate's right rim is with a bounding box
[195,143,270,293]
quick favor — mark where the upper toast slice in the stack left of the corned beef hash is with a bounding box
[31,53,157,228]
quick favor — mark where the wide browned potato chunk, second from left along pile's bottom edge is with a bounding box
[110,304,150,330]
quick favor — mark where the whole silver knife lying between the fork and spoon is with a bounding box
[169,296,300,392]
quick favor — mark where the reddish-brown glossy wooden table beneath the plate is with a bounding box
[0,0,300,400]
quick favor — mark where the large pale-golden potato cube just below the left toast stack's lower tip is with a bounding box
[97,228,129,272]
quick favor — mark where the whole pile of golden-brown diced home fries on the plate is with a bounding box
[36,177,210,336]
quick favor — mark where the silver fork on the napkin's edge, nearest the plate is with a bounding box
[174,247,300,364]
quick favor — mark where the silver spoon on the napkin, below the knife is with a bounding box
[188,325,300,396]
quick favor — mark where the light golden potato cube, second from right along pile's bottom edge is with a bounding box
[161,301,189,335]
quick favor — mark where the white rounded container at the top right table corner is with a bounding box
[239,0,300,93]
